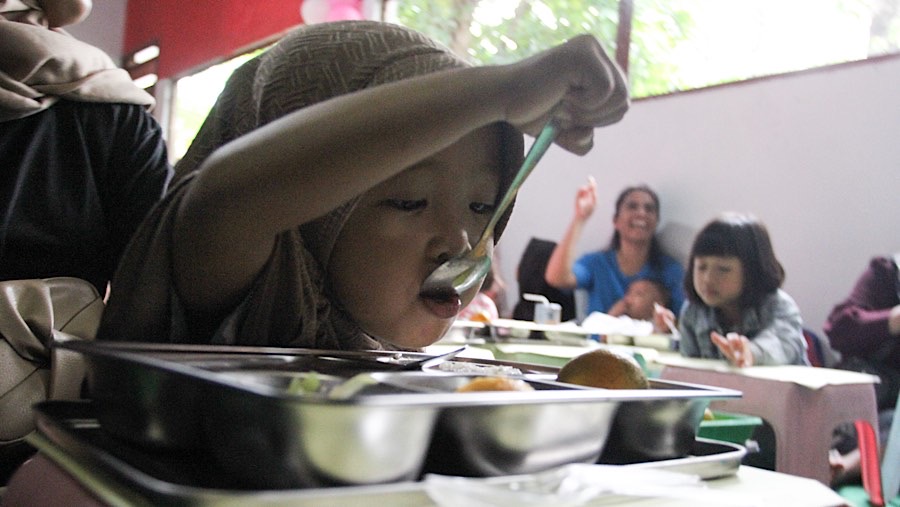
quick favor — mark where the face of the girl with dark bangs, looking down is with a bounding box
[694,255,744,308]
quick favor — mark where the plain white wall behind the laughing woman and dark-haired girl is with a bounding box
[498,57,900,338]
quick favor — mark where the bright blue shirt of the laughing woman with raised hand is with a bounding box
[572,250,684,314]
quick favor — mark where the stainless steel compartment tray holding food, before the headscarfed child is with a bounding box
[62,342,740,489]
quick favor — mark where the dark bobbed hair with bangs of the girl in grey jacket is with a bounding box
[684,213,784,308]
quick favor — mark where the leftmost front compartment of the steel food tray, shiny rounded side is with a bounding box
[202,391,439,489]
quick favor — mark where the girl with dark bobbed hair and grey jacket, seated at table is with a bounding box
[656,213,808,367]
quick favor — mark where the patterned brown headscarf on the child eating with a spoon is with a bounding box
[175,21,523,267]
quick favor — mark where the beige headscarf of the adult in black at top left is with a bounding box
[0,0,154,122]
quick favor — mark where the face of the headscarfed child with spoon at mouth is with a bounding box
[328,127,501,348]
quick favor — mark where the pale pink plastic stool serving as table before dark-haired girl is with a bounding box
[660,358,878,485]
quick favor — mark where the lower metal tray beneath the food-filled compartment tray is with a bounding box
[29,401,746,507]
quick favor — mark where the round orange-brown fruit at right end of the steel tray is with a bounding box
[556,349,650,389]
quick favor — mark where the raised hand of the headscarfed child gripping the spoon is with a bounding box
[501,35,629,155]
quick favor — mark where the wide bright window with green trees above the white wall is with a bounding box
[385,0,900,98]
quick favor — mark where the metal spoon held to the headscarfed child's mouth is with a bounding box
[422,121,559,299]
